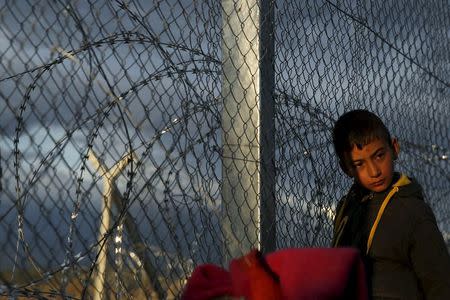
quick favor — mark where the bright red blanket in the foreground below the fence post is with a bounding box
[182,248,368,300]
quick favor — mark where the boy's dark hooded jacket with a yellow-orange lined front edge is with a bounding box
[333,173,450,300]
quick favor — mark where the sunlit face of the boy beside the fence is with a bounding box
[347,139,399,192]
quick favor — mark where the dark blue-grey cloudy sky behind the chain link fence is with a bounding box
[0,0,450,292]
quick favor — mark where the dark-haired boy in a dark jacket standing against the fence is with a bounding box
[333,110,450,300]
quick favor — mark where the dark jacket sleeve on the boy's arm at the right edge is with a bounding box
[409,201,450,300]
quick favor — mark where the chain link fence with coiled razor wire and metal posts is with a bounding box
[0,0,450,299]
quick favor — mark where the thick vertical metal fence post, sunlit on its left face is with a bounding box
[222,0,275,263]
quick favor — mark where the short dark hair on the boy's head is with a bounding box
[333,109,391,162]
